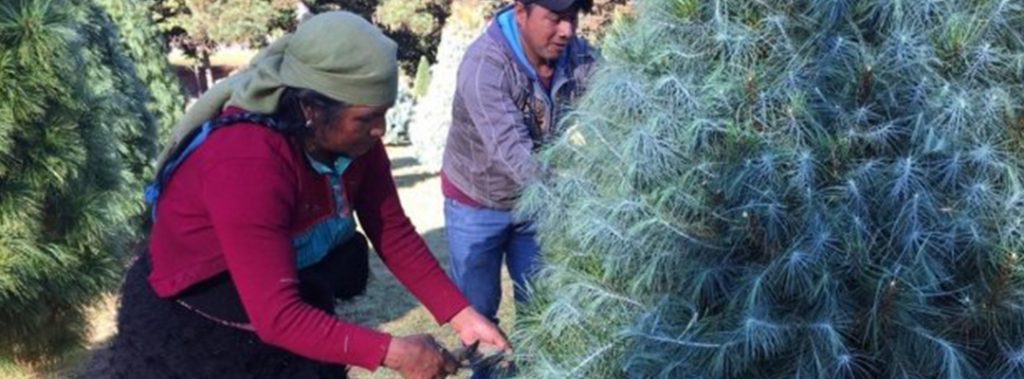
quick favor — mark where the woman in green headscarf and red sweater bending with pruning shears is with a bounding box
[85,12,509,379]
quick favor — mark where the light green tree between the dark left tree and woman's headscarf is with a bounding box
[96,0,185,140]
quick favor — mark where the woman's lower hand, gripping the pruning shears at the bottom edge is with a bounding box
[384,334,459,379]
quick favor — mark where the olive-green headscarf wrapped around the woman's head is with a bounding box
[157,11,398,168]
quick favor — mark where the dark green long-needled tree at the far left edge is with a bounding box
[0,0,157,360]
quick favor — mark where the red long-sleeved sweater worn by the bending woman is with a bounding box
[150,109,469,370]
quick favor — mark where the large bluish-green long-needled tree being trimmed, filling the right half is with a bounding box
[513,0,1024,378]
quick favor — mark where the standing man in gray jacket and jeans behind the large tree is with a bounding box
[441,0,595,378]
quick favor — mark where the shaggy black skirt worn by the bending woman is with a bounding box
[78,235,369,379]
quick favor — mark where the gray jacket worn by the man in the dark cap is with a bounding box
[441,8,595,210]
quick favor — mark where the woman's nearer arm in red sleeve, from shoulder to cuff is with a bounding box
[202,126,391,370]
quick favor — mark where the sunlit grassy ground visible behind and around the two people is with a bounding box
[0,146,514,379]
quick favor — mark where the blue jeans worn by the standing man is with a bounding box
[444,199,541,379]
